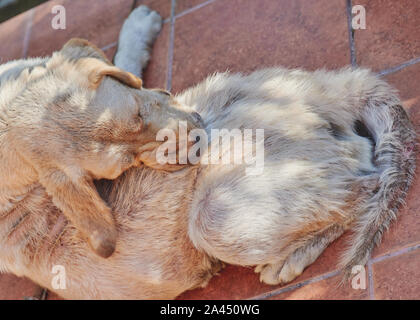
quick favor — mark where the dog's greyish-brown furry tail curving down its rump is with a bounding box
[341,74,416,276]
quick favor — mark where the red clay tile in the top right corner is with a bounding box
[353,0,420,71]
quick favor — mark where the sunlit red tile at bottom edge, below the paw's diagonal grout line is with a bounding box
[269,275,369,300]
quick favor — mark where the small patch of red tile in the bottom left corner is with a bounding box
[0,274,40,300]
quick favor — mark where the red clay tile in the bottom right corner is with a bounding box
[372,249,420,299]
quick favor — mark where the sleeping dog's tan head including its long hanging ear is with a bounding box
[10,39,200,256]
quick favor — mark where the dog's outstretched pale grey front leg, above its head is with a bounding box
[114,6,162,77]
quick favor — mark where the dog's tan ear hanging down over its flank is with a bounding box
[39,168,117,258]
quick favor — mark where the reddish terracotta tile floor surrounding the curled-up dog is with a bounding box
[0,0,420,299]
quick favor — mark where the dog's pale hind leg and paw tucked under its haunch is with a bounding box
[255,225,344,285]
